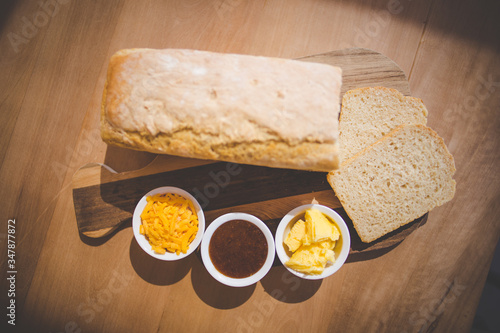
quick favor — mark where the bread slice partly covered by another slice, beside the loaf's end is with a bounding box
[339,87,427,161]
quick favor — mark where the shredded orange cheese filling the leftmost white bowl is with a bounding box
[139,193,198,255]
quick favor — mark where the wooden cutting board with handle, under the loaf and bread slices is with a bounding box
[72,48,427,261]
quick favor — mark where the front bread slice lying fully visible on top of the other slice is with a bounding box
[327,125,455,243]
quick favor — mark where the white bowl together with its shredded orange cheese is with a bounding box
[132,186,205,261]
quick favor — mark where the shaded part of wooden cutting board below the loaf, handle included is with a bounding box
[73,162,427,261]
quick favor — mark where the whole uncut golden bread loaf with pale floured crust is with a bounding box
[101,49,342,171]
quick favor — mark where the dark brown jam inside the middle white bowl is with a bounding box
[208,220,267,278]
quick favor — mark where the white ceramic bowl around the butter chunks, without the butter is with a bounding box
[275,204,351,280]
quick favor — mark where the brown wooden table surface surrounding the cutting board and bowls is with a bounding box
[0,0,500,332]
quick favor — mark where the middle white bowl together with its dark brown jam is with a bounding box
[201,213,275,287]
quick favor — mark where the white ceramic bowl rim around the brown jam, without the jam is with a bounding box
[201,213,275,287]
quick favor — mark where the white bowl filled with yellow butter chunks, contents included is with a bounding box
[275,204,351,280]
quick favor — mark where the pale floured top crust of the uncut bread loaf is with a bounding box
[103,49,342,144]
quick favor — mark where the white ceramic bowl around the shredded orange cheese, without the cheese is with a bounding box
[132,186,205,261]
